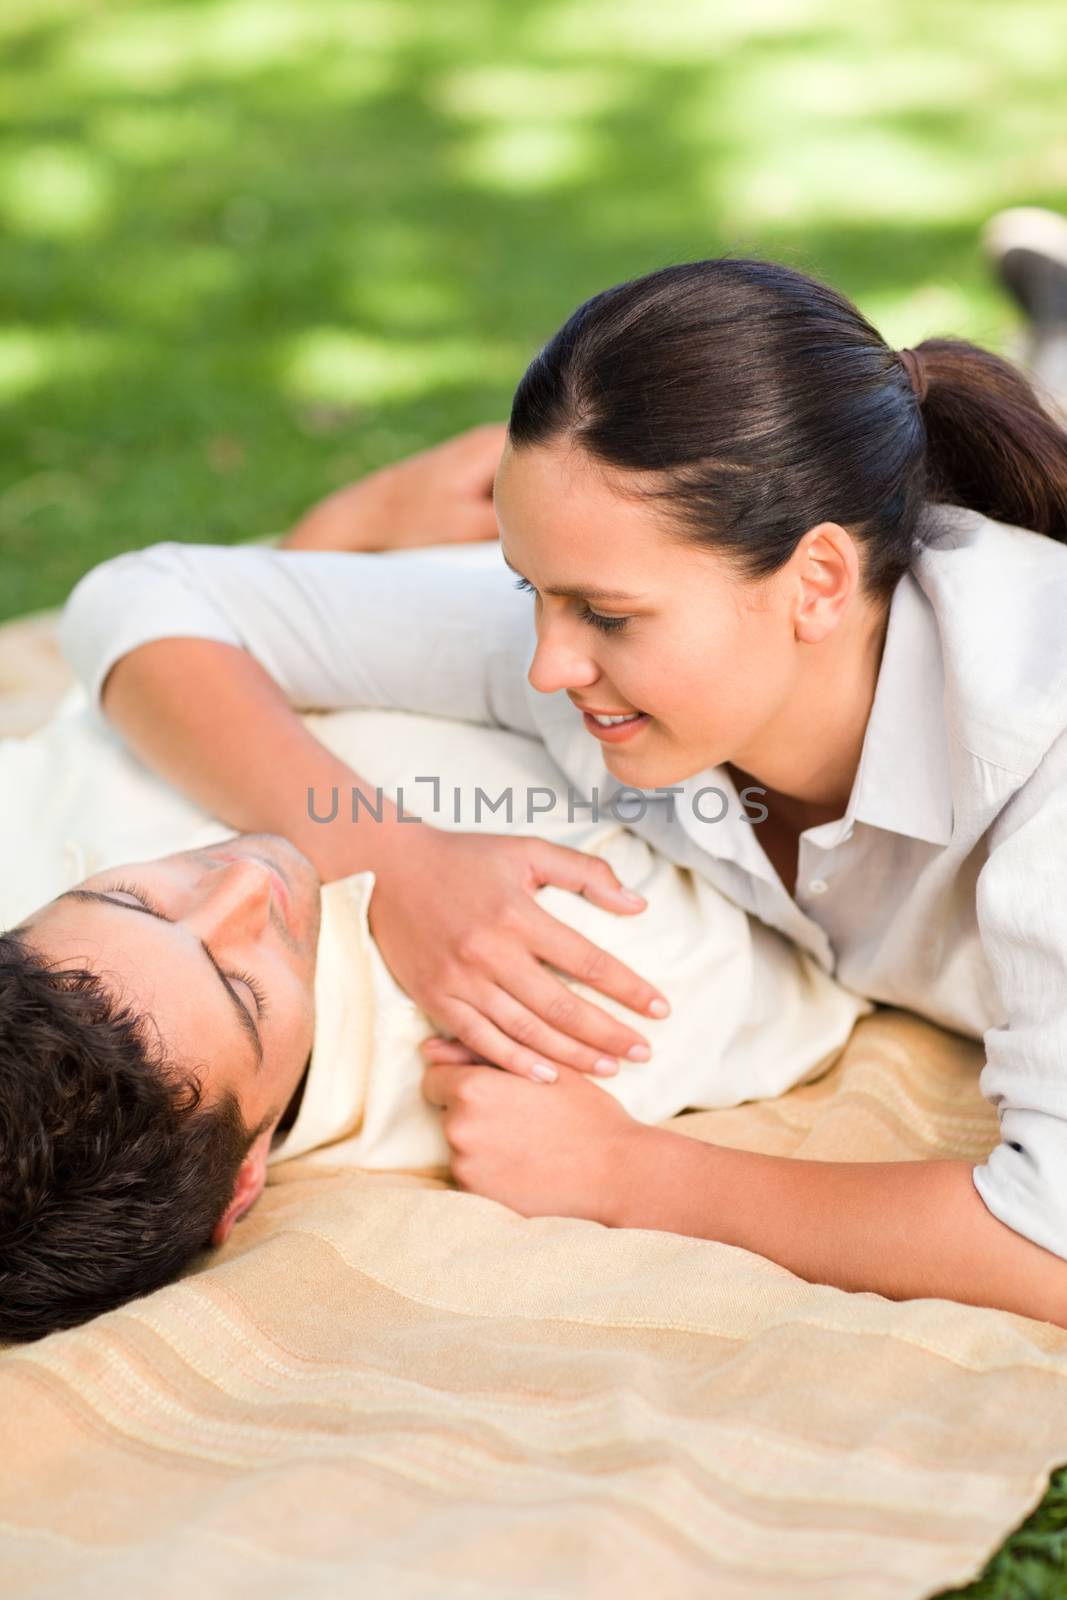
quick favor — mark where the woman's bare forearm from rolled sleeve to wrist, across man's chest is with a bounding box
[102,638,411,883]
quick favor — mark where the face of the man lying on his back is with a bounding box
[22,834,320,1126]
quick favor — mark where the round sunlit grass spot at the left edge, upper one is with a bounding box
[0,144,112,238]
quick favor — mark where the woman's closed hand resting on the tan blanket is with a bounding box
[421,1037,648,1227]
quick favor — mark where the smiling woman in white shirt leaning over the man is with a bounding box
[67,261,1067,1323]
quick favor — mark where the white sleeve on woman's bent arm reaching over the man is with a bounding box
[59,542,537,736]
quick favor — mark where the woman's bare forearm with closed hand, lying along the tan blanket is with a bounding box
[422,1040,1067,1326]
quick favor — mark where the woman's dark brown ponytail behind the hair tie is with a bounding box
[915,339,1067,542]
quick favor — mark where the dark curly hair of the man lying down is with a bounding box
[0,930,266,1341]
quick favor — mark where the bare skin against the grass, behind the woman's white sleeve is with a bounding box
[278,422,507,550]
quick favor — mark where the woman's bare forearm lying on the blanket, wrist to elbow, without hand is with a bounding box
[609,1125,1067,1326]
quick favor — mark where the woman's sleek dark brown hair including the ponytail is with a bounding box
[509,258,1067,598]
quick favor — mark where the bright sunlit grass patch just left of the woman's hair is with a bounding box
[280,328,518,405]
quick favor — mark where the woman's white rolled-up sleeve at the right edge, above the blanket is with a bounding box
[973,734,1067,1259]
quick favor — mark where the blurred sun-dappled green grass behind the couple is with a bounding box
[0,0,1067,618]
